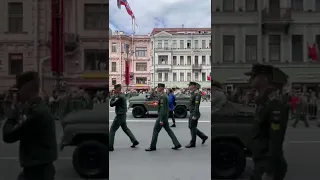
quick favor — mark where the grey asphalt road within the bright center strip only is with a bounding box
[109,102,211,180]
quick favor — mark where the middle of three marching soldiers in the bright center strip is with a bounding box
[146,83,181,151]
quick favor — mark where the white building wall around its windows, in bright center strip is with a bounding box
[151,32,211,87]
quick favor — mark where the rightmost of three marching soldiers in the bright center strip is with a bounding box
[186,82,208,148]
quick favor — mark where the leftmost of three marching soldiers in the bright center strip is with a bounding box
[109,84,139,151]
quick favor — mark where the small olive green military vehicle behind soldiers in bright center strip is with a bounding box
[128,94,190,118]
